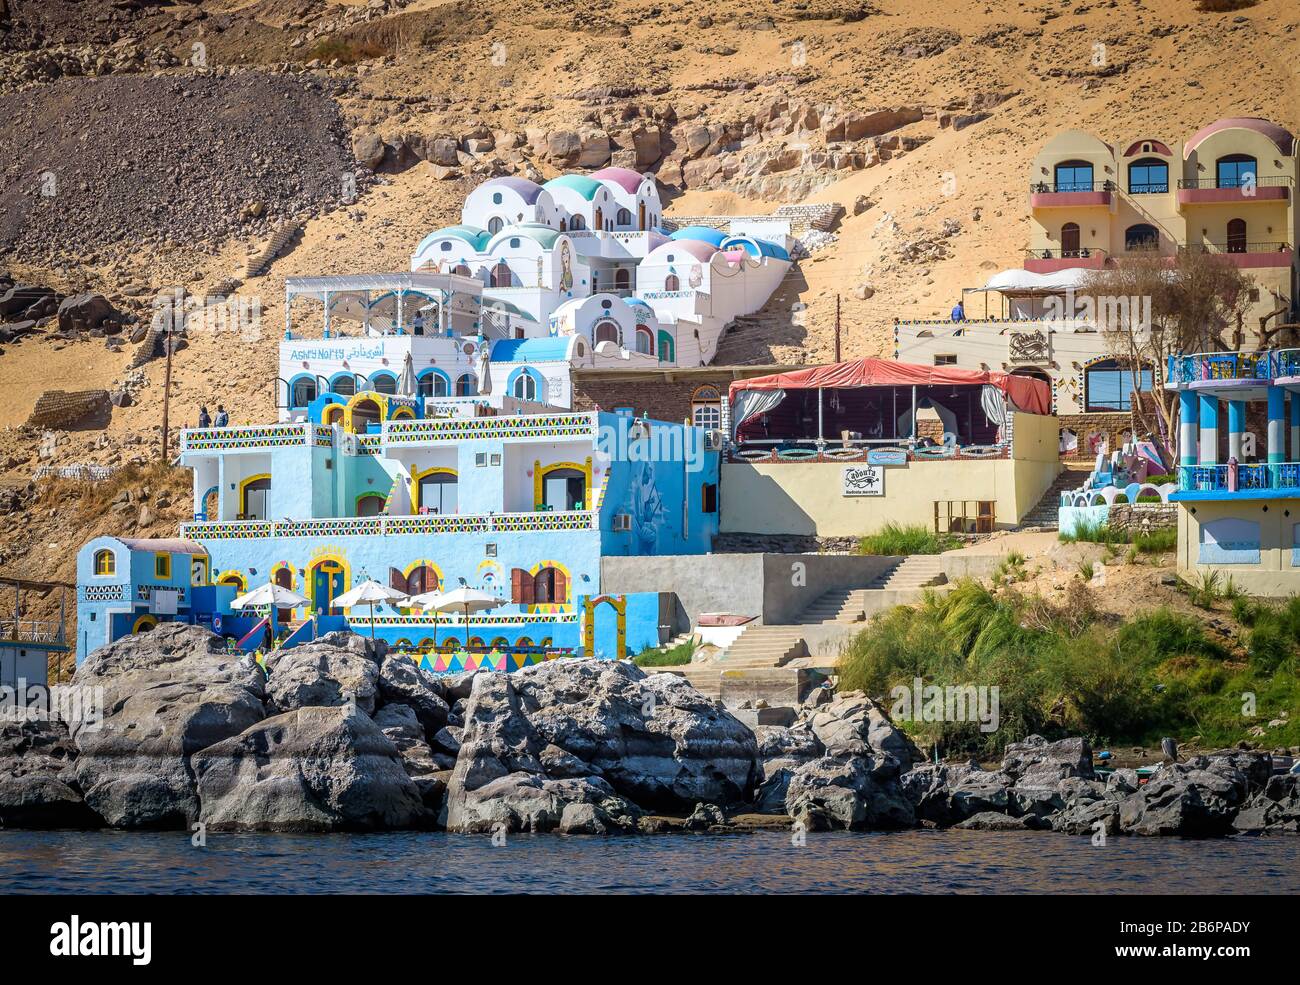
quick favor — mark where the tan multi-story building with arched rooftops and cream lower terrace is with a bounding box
[894,118,1300,455]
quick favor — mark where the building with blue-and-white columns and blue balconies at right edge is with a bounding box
[1165,350,1300,596]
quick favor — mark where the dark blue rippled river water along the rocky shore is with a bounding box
[0,830,1300,894]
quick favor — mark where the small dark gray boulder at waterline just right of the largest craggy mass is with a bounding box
[785,756,917,830]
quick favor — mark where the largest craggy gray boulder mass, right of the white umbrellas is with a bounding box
[443,660,757,833]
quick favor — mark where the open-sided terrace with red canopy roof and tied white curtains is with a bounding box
[728,359,1052,444]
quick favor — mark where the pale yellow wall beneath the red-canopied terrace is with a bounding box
[722,415,1061,537]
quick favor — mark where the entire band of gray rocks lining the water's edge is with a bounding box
[0,624,1300,837]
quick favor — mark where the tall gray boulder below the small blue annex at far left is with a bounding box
[72,622,265,828]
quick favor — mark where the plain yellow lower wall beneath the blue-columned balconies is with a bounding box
[1178,499,1300,598]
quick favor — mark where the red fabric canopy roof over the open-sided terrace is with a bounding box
[728,359,1052,415]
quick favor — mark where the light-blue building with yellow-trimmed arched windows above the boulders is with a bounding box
[78,391,719,669]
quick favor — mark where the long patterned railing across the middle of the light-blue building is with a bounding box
[181,509,598,541]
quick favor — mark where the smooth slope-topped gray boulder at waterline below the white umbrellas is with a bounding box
[192,707,433,832]
